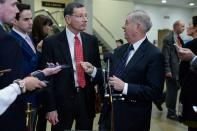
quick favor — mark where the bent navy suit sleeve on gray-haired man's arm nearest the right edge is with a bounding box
[127,53,164,101]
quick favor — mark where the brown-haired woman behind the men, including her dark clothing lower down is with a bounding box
[32,15,53,131]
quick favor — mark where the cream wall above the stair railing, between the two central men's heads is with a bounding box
[93,0,133,48]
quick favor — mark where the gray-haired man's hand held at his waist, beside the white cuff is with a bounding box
[109,76,125,91]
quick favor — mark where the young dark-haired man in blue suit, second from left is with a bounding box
[11,3,38,76]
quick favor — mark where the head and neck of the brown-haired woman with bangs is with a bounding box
[32,15,53,52]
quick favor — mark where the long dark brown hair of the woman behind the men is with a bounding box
[32,15,53,44]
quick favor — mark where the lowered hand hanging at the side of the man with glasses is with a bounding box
[46,111,59,125]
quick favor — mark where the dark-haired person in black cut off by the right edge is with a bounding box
[179,16,197,131]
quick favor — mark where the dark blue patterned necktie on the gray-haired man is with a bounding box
[114,44,134,77]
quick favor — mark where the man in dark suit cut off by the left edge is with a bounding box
[0,0,25,131]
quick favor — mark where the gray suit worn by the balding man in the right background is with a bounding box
[162,31,180,115]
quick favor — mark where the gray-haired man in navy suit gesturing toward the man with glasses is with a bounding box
[82,11,164,131]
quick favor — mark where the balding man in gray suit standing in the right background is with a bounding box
[162,20,185,120]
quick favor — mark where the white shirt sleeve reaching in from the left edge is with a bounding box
[0,83,21,115]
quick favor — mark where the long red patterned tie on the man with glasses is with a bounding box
[74,35,86,88]
